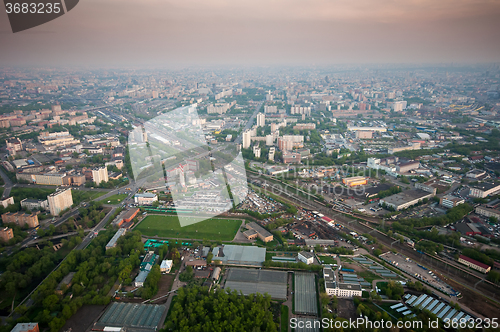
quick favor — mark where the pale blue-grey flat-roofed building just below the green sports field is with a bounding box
[212,244,266,266]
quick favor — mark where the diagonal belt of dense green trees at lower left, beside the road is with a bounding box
[11,231,144,332]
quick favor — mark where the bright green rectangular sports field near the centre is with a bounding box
[135,215,241,241]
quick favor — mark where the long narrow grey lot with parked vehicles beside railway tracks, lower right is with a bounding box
[380,252,455,295]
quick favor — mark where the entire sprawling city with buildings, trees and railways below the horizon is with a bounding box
[0,65,500,332]
